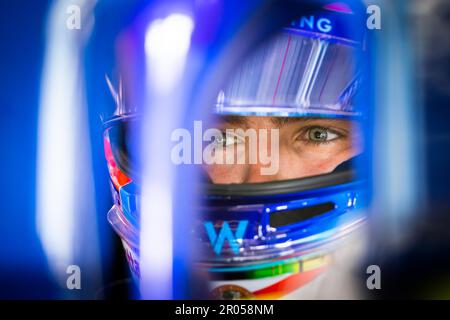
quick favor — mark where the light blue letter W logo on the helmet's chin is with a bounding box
[204,220,248,255]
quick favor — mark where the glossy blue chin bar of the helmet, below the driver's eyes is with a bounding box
[196,154,365,266]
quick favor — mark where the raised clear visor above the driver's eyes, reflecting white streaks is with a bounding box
[216,29,362,117]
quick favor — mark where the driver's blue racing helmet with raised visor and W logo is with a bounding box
[104,3,367,299]
